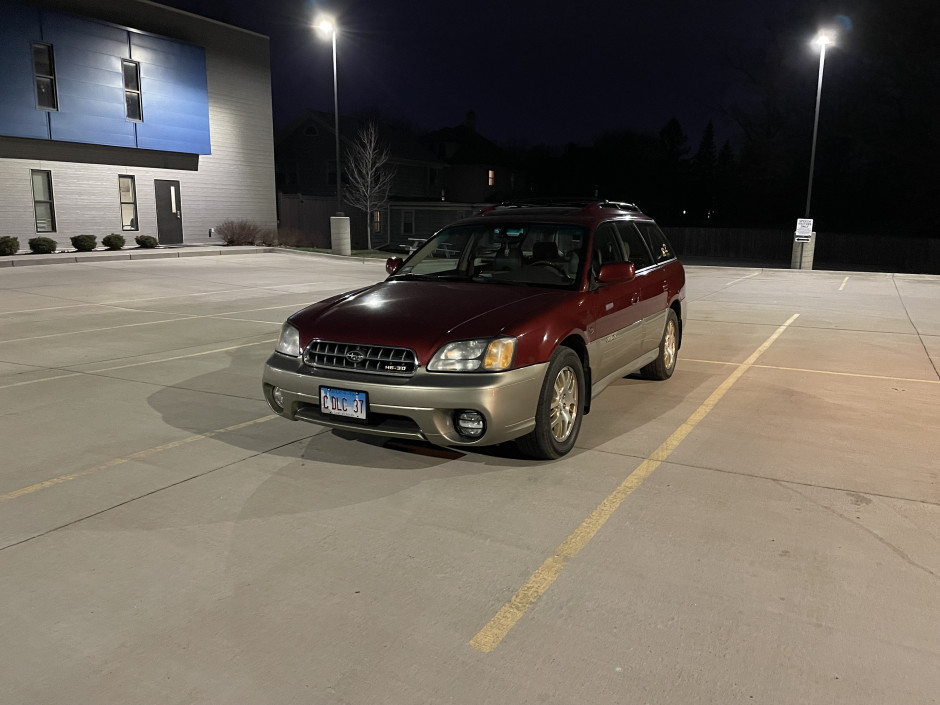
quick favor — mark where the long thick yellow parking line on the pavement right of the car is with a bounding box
[470,313,799,653]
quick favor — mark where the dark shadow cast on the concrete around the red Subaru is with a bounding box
[148,345,701,482]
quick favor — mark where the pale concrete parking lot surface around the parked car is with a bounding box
[0,253,940,705]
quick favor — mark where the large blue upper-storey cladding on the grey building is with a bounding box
[0,2,211,154]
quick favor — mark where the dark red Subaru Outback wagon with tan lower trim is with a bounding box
[263,200,685,459]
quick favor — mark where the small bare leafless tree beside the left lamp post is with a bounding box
[343,122,395,250]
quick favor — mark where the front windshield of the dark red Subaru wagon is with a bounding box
[395,223,587,288]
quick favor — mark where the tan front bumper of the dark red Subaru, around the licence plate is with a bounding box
[262,353,548,446]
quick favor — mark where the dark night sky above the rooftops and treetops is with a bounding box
[154,0,792,147]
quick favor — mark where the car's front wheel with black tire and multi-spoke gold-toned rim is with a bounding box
[516,348,585,460]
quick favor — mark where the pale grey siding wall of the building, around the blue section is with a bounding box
[0,0,277,248]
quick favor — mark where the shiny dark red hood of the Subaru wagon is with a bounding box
[290,279,571,364]
